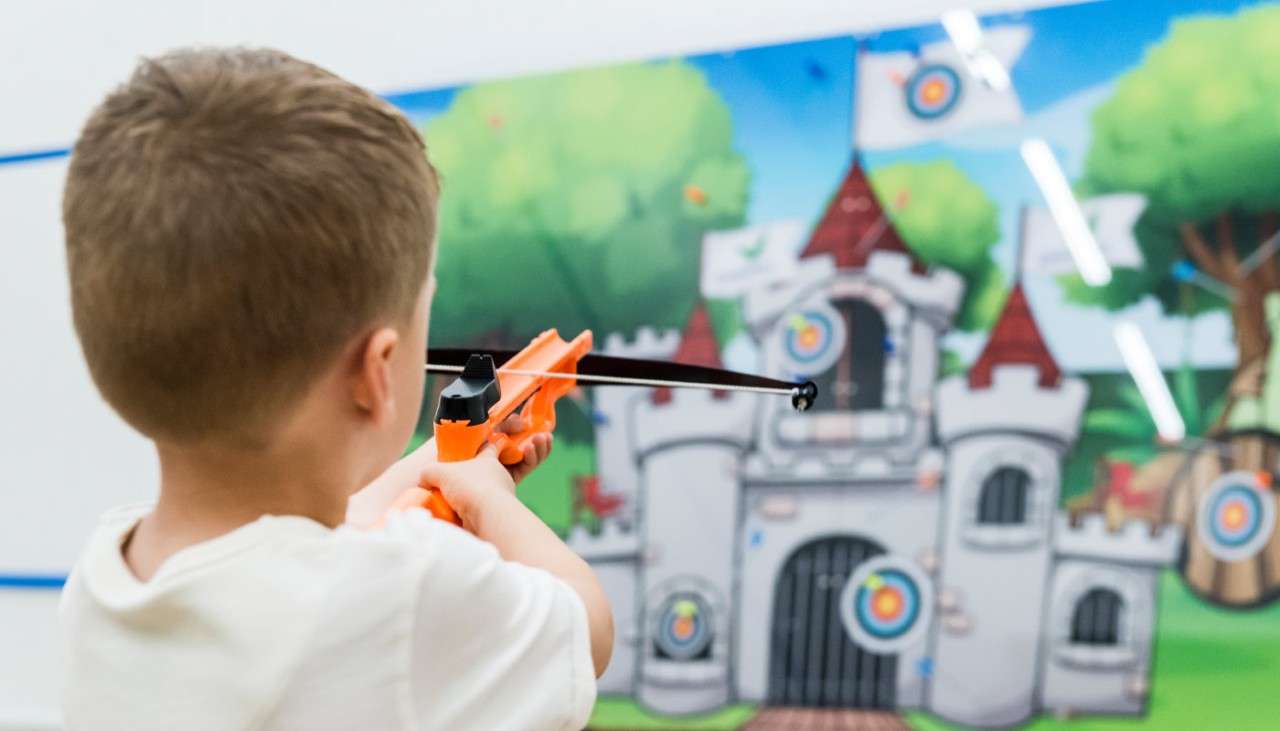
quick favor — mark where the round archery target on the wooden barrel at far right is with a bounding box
[1196,470,1276,561]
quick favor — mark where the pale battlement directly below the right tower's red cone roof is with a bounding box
[937,365,1089,449]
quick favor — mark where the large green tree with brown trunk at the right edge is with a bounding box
[1064,8,1280,367]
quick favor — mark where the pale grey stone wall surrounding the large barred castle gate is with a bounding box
[735,483,940,708]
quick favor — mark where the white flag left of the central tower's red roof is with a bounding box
[701,219,806,300]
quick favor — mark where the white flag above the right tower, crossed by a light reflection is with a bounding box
[1023,193,1147,274]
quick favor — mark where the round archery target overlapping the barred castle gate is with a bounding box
[840,556,933,653]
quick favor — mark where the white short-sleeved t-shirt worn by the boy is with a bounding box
[60,506,595,731]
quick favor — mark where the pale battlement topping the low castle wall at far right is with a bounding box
[1053,512,1183,566]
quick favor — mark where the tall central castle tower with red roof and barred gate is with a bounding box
[735,157,964,708]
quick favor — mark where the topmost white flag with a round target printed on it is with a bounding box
[854,26,1030,150]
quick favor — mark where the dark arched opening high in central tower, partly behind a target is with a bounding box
[813,300,888,411]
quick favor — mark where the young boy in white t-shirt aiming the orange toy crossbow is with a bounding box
[61,50,613,731]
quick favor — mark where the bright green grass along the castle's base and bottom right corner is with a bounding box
[591,571,1280,731]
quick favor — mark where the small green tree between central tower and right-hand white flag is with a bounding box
[870,160,1005,330]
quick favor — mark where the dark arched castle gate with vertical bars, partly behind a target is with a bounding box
[768,535,897,708]
